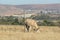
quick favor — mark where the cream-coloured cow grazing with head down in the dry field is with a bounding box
[25,19,39,32]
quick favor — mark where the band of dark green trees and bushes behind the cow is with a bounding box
[0,16,60,26]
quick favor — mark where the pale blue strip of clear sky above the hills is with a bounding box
[0,0,60,5]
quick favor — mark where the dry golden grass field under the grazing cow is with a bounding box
[0,25,60,40]
